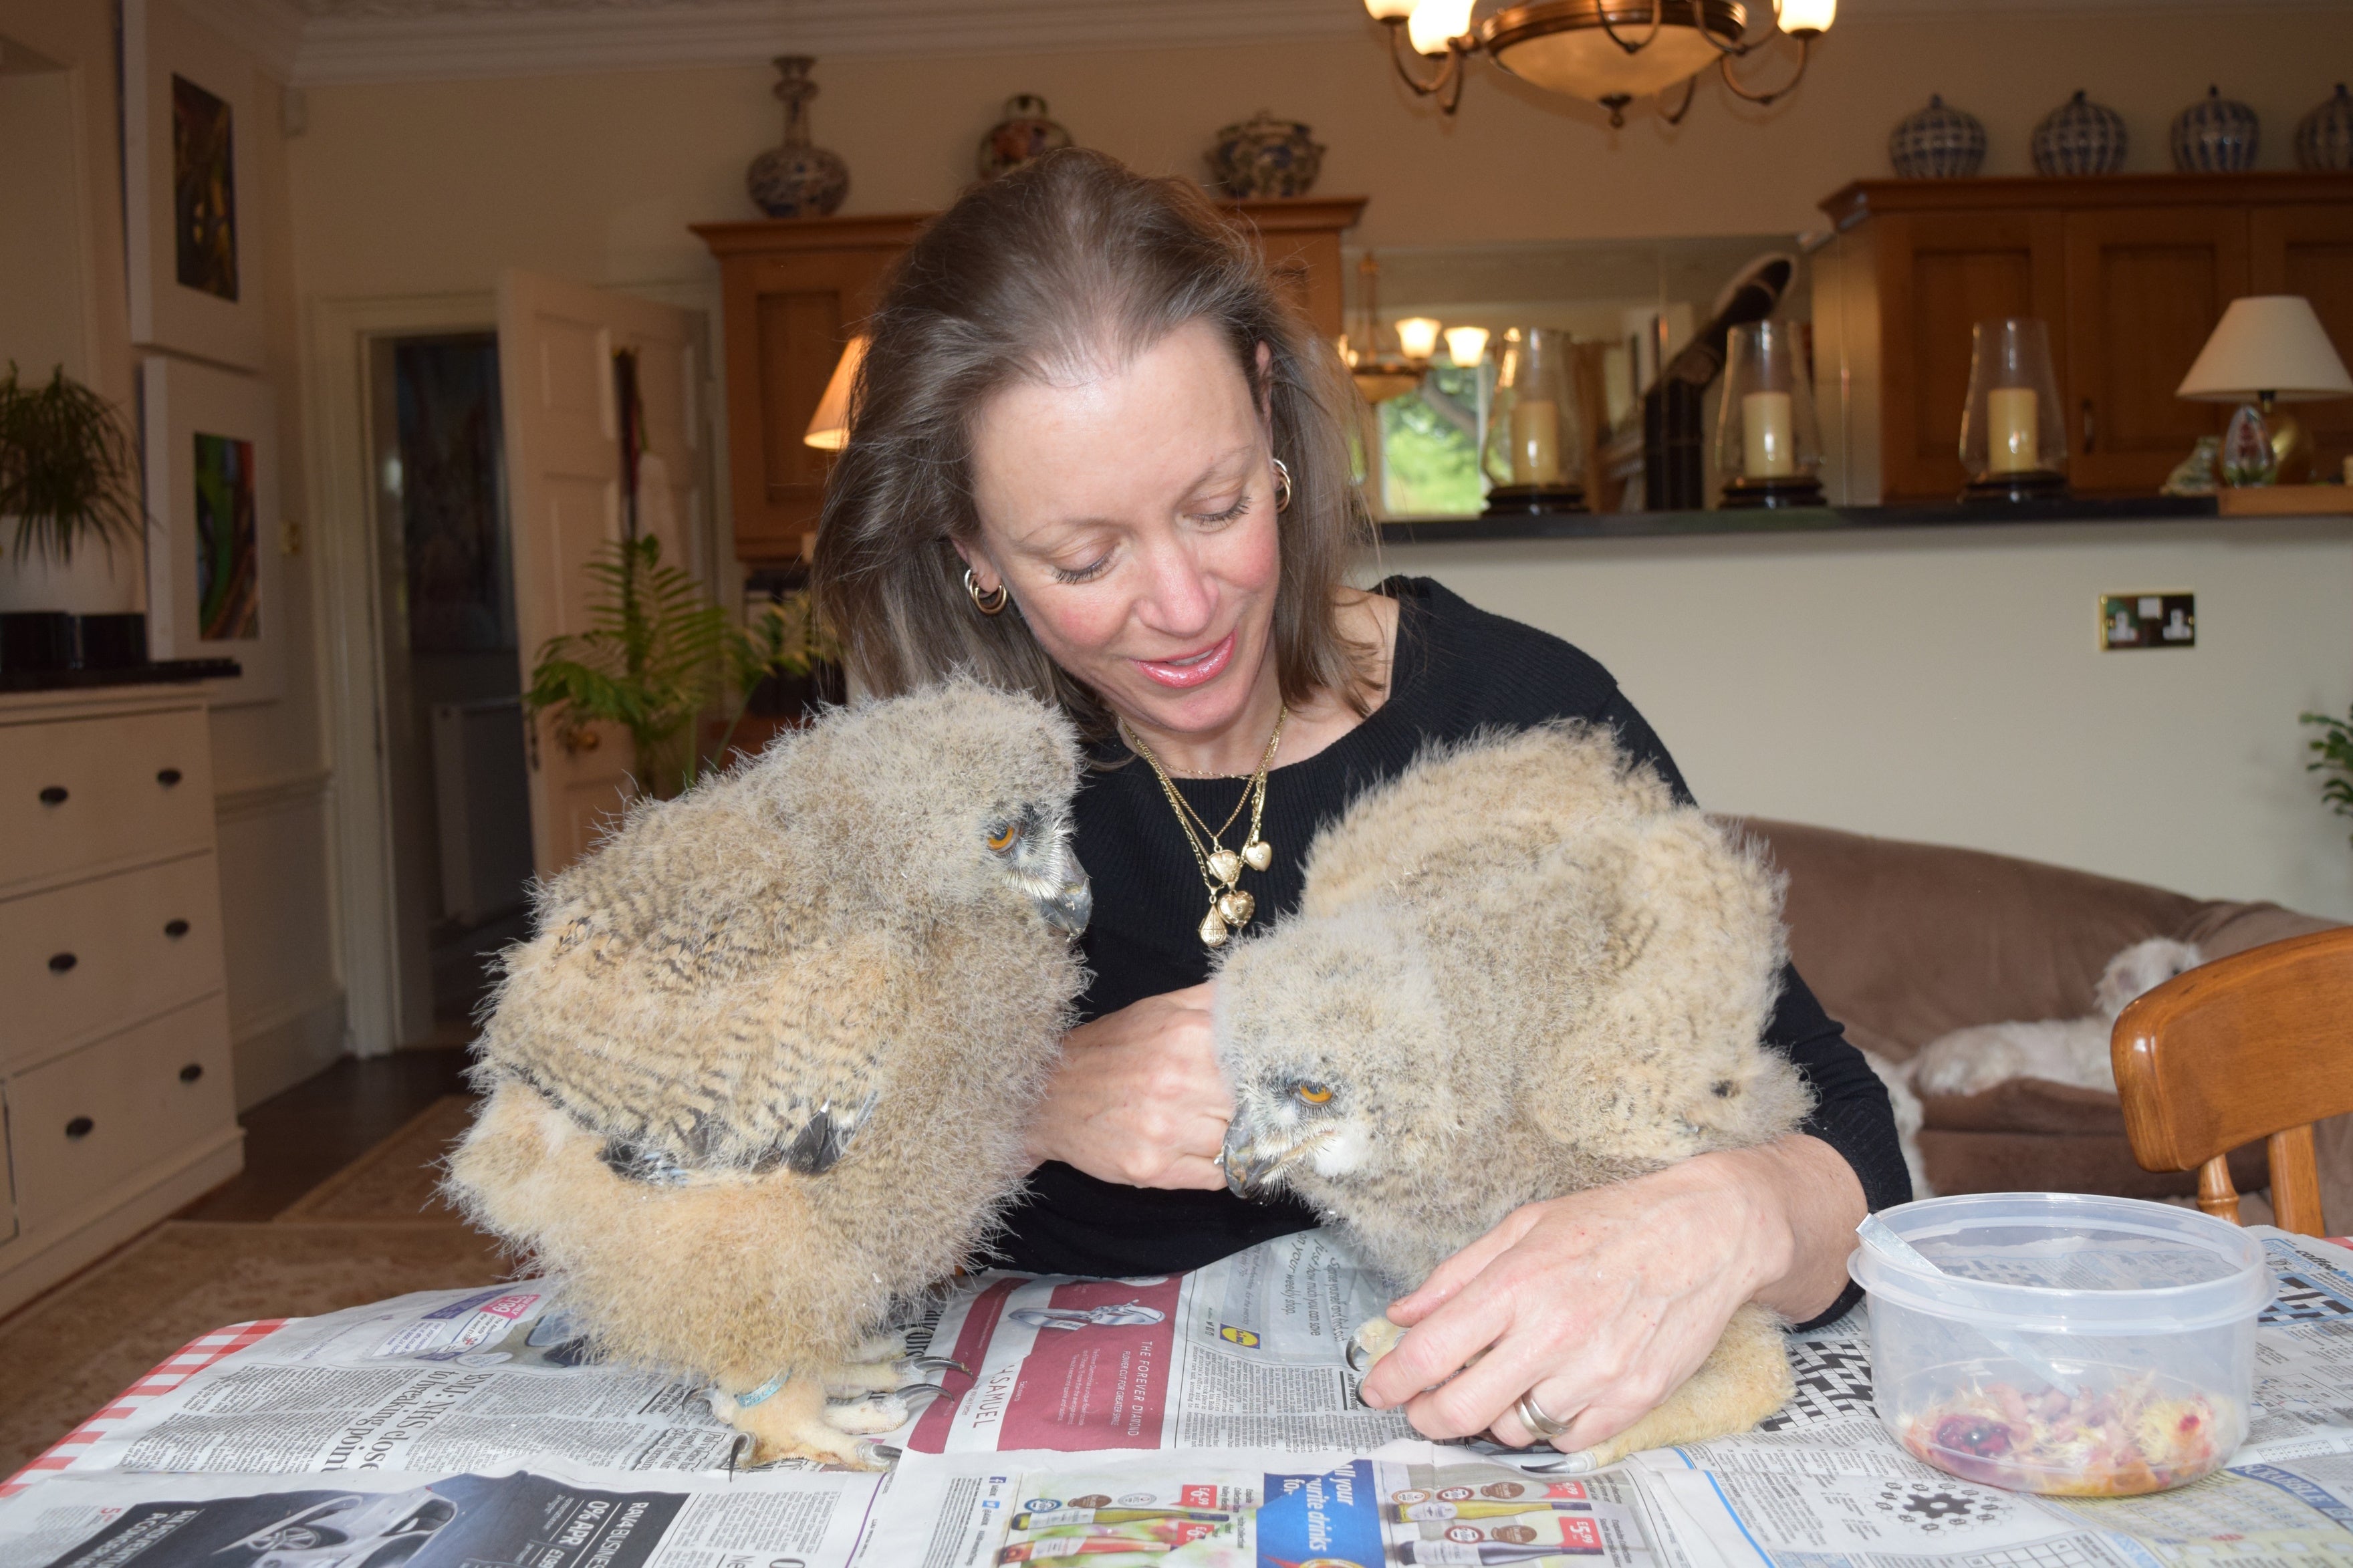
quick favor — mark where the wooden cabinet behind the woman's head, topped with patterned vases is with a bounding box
[694,198,1365,565]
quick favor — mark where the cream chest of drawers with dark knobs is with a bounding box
[0,685,245,1311]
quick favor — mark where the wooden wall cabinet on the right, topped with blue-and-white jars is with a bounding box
[1814,174,2353,504]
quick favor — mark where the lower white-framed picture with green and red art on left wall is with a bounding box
[141,356,287,706]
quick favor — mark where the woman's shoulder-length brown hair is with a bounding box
[814,148,1376,737]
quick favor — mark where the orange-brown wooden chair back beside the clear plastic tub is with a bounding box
[2108,928,2353,1236]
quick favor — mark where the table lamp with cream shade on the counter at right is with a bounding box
[2174,294,2353,485]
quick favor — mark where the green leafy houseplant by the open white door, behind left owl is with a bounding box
[522,535,826,798]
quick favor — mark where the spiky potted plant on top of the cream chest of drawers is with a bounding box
[0,362,146,671]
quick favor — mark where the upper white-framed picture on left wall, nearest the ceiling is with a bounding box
[122,0,261,370]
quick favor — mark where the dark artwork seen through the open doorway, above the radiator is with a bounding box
[393,332,515,654]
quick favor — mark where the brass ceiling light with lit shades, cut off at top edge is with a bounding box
[1365,0,1838,125]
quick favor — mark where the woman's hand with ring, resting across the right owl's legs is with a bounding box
[1365,1135,1864,1452]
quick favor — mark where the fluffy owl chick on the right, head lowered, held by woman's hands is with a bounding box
[1214,725,1812,1464]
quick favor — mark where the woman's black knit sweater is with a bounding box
[997,577,1910,1311]
